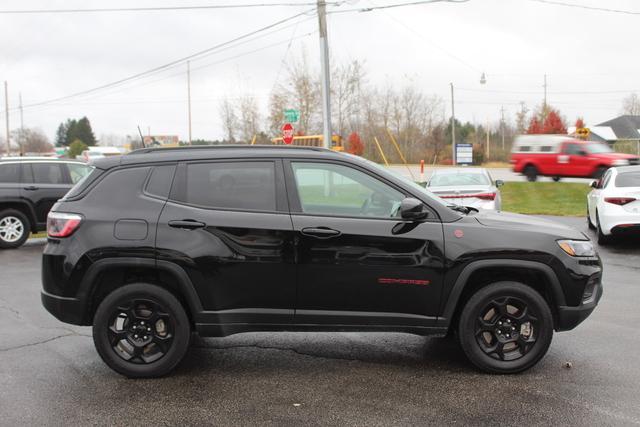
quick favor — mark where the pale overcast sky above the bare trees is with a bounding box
[0,0,640,144]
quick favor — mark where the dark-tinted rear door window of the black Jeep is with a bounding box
[172,161,276,212]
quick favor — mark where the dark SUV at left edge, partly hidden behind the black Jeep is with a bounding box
[0,157,91,249]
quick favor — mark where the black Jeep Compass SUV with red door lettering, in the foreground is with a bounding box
[42,146,602,377]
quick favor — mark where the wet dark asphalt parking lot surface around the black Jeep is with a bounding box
[0,218,640,426]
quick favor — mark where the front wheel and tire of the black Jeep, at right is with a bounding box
[458,282,553,374]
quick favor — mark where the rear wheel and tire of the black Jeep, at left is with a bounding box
[93,283,191,378]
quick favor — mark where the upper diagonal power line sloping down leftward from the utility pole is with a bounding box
[16,9,313,108]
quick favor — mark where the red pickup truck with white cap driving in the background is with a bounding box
[511,135,640,181]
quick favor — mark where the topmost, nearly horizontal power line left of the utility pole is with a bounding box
[0,2,341,15]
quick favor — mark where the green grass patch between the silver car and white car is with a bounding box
[500,182,591,216]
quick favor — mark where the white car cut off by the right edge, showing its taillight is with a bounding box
[587,166,640,245]
